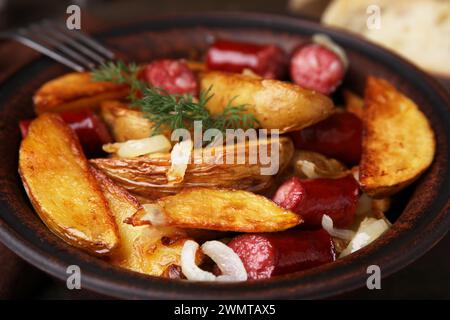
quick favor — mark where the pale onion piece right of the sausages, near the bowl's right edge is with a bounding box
[339,218,390,258]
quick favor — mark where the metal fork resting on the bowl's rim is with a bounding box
[0,20,114,72]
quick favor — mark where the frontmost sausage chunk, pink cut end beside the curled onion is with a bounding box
[228,230,335,280]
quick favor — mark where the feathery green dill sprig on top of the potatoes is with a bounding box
[92,61,258,134]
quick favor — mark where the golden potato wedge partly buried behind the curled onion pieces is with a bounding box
[92,168,196,276]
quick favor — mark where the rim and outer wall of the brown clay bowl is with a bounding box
[0,12,450,299]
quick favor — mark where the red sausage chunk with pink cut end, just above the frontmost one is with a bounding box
[273,175,359,227]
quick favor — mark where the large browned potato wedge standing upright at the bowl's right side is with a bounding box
[359,77,435,197]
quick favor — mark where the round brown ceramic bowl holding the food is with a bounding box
[0,14,450,299]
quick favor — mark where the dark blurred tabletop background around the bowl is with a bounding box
[0,0,450,299]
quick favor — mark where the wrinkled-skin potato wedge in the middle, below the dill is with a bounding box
[90,137,294,199]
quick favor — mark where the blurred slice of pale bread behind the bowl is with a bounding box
[322,0,450,77]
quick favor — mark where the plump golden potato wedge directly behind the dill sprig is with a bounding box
[200,71,334,133]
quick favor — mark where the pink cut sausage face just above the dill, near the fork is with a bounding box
[144,59,198,95]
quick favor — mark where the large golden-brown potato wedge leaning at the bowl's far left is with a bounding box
[19,113,119,254]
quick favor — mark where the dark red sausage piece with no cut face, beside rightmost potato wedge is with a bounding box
[291,112,363,165]
